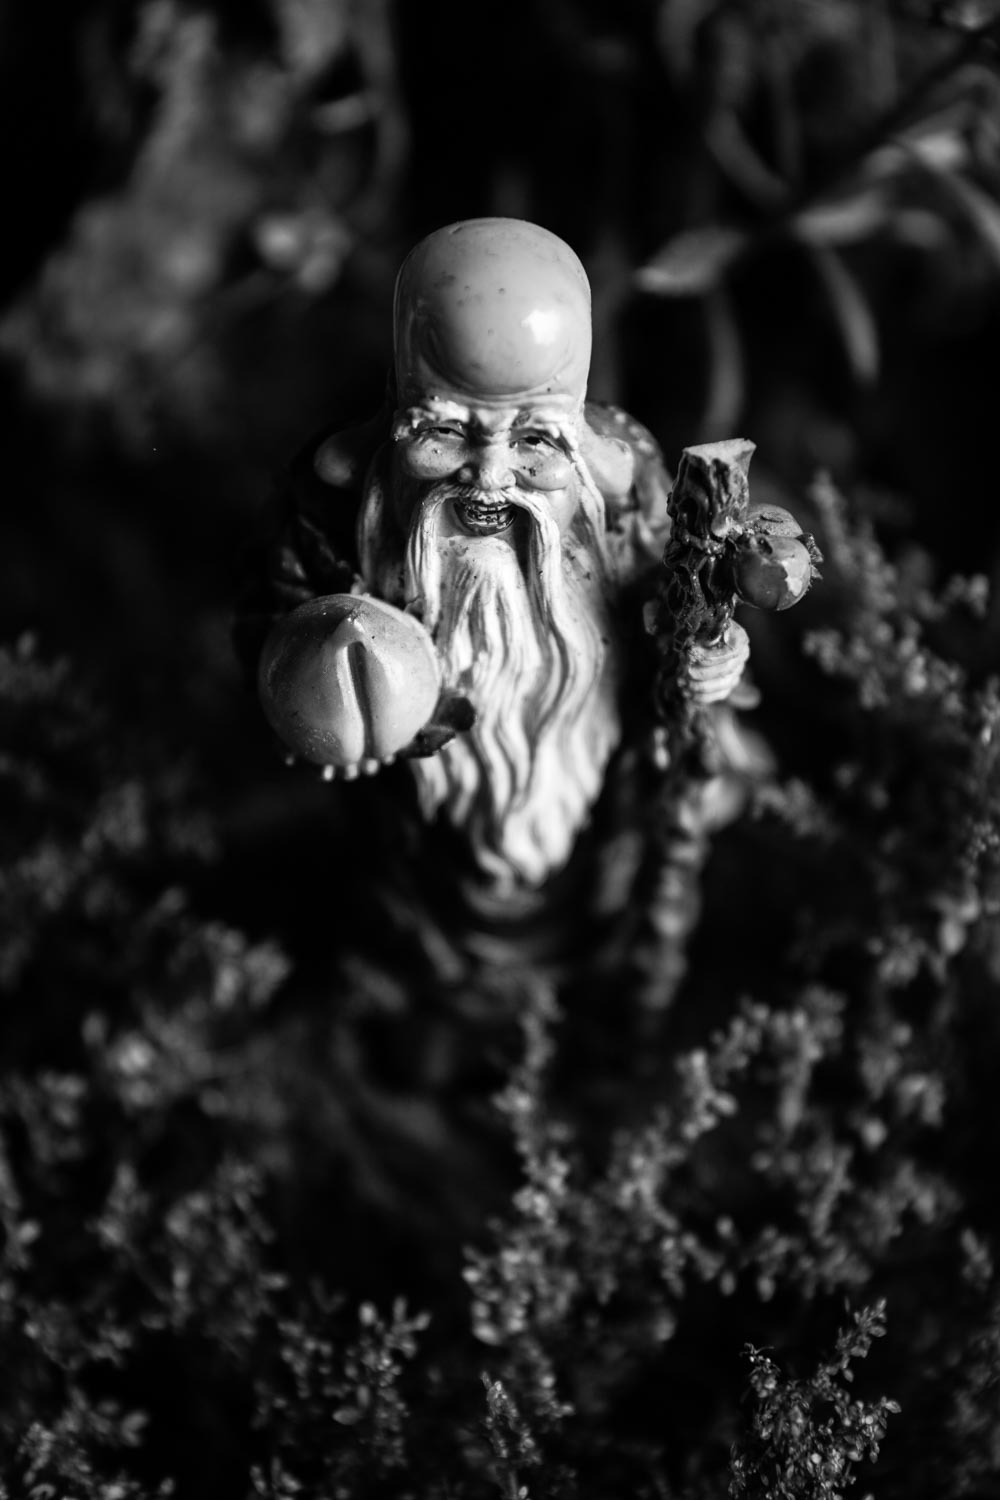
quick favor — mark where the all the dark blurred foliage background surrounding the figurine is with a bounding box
[0,0,1000,1500]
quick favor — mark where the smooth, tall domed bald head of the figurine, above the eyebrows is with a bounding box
[394,219,591,407]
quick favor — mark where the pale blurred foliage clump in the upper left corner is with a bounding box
[0,0,399,447]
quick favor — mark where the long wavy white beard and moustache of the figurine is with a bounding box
[403,485,619,891]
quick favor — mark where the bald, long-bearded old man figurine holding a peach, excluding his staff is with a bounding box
[237,219,815,1002]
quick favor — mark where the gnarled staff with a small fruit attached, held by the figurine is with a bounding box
[631,438,822,1008]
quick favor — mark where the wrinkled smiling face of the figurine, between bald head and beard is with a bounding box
[393,396,577,537]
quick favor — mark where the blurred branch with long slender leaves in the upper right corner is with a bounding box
[637,0,1000,434]
